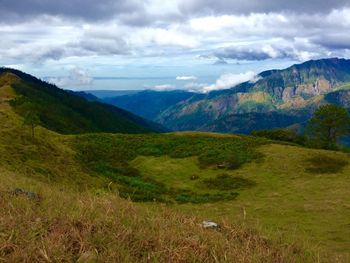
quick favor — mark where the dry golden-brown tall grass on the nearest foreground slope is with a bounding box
[0,171,308,262]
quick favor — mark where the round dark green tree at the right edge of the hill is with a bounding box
[306,104,350,149]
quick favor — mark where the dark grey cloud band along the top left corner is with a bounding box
[0,0,143,22]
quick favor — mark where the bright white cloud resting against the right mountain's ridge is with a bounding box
[202,71,258,92]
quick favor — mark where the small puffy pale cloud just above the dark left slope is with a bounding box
[47,67,93,88]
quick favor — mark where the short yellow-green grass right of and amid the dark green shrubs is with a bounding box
[132,144,350,262]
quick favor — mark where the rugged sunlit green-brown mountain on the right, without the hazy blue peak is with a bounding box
[155,59,350,132]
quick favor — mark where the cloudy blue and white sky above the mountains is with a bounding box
[0,0,350,92]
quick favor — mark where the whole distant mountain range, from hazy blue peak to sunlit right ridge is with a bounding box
[105,58,350,133]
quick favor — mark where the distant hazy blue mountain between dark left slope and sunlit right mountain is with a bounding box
[104,90,195,120]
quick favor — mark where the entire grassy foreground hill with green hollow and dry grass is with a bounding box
[0,71,350,262]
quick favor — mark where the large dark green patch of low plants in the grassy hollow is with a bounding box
[71,133,263,203]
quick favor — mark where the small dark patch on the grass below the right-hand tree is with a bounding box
[306,154,349,174]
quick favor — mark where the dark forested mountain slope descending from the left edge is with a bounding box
[0,68,162,134]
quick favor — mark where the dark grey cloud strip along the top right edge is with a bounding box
[180,0,350,14]
